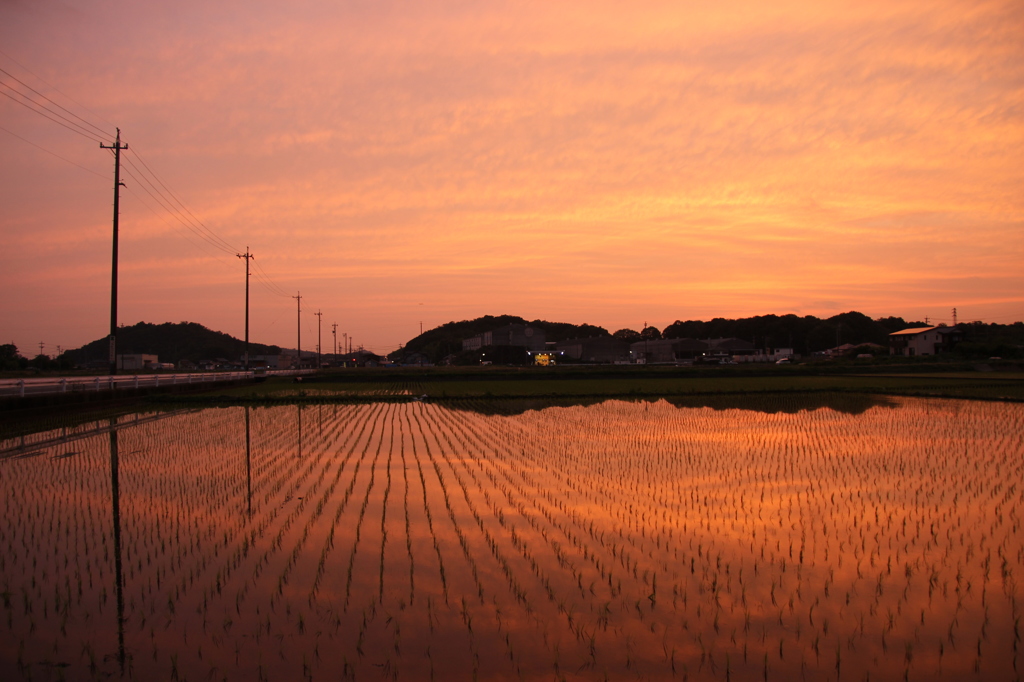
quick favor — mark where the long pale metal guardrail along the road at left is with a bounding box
[0,370,315,397]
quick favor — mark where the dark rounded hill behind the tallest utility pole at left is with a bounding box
[67,323,281,365]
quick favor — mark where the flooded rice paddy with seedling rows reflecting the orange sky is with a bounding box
[0,398,1024,680]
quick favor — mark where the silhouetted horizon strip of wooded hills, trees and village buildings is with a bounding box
[8,311,999,372]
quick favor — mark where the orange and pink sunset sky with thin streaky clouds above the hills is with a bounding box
[0,0,1024,356]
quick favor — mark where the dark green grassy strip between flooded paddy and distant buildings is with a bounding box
[186,367,1024,402]
